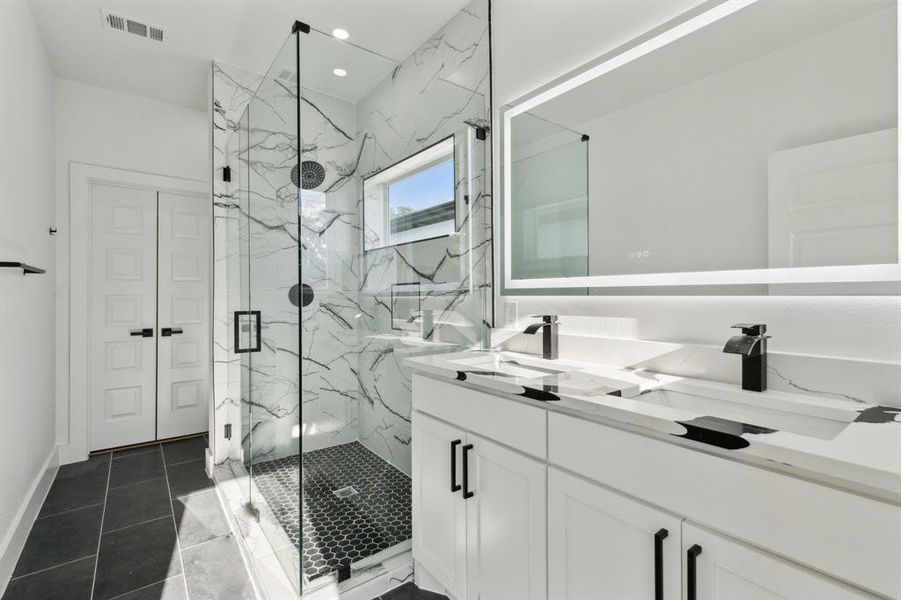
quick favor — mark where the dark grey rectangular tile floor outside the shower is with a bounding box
[3,437,254,600]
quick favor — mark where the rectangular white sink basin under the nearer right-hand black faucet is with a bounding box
[634,385,858,440]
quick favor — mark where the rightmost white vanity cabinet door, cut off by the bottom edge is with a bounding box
[682,522,875,600]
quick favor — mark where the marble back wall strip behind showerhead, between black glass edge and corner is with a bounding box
[300,89,361,452]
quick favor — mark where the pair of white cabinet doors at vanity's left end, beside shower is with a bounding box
[413,382,547,600]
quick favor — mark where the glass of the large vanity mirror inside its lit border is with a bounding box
[506,0,899,293]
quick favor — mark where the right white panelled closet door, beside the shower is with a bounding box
[157,192,212,439]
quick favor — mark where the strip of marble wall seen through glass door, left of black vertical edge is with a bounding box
[238,62,300,462]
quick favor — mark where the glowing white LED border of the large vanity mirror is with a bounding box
[501,0,901,295]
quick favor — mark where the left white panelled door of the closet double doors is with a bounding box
[88,183,157,450]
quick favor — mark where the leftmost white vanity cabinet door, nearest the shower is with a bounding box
[413,411,466,598]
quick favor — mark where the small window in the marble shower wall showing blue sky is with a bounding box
[363,137,456,251]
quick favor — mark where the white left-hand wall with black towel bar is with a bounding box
[0,1,56,593]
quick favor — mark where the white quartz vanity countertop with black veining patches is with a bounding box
[405,351,901,503]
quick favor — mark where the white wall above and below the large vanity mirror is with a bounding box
[492,0,901,363]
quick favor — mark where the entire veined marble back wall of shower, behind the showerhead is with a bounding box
[213,59,359,464]
